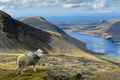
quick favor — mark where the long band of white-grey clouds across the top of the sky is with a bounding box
[0,0,117,10]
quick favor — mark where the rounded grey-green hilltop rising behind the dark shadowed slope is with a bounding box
[20,16,64,33]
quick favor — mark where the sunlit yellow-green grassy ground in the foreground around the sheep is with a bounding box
[0,49,120,80]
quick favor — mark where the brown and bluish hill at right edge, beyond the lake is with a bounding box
[79,19,120,42]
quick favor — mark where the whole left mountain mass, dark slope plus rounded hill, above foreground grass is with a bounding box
[0,11,85,53]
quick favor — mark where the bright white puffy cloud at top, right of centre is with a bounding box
[63,0,107,10]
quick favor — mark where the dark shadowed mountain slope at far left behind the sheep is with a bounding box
[0,11,51,50]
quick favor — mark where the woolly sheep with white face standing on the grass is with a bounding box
[16,49,44,74]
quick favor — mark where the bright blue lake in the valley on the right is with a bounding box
[67,32,120,57]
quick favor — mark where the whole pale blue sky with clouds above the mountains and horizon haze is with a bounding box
[0,0,120,16]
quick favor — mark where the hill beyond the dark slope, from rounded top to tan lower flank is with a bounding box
[20,16,85,51]
